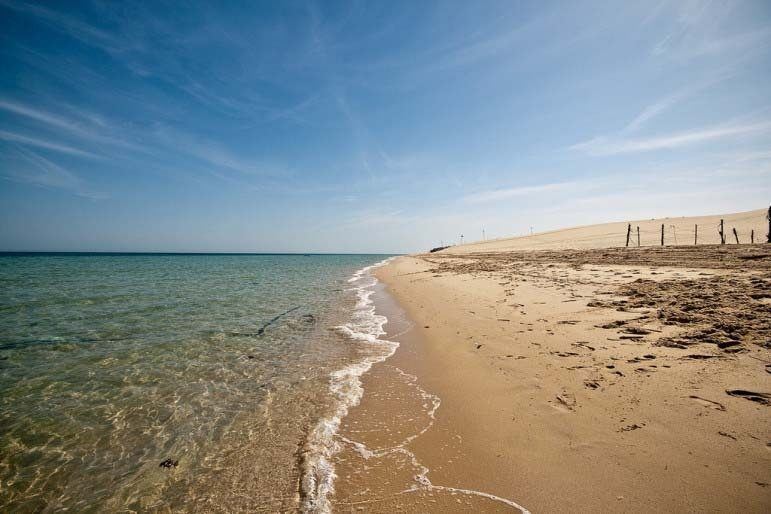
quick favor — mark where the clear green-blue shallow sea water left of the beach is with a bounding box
[0,255,392,512]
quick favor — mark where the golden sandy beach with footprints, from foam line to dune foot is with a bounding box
[335,211,771,512]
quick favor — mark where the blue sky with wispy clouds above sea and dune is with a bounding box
[0,0,771,253]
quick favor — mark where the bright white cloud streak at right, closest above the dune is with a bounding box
[570,121,771,156]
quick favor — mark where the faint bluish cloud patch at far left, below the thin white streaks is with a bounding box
[3,147,108,200]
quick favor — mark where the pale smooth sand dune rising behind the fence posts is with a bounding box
[442,205,768,253]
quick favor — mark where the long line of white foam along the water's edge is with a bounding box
[301,259,399,513]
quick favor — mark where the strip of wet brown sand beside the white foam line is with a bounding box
[332,257,529,514]
